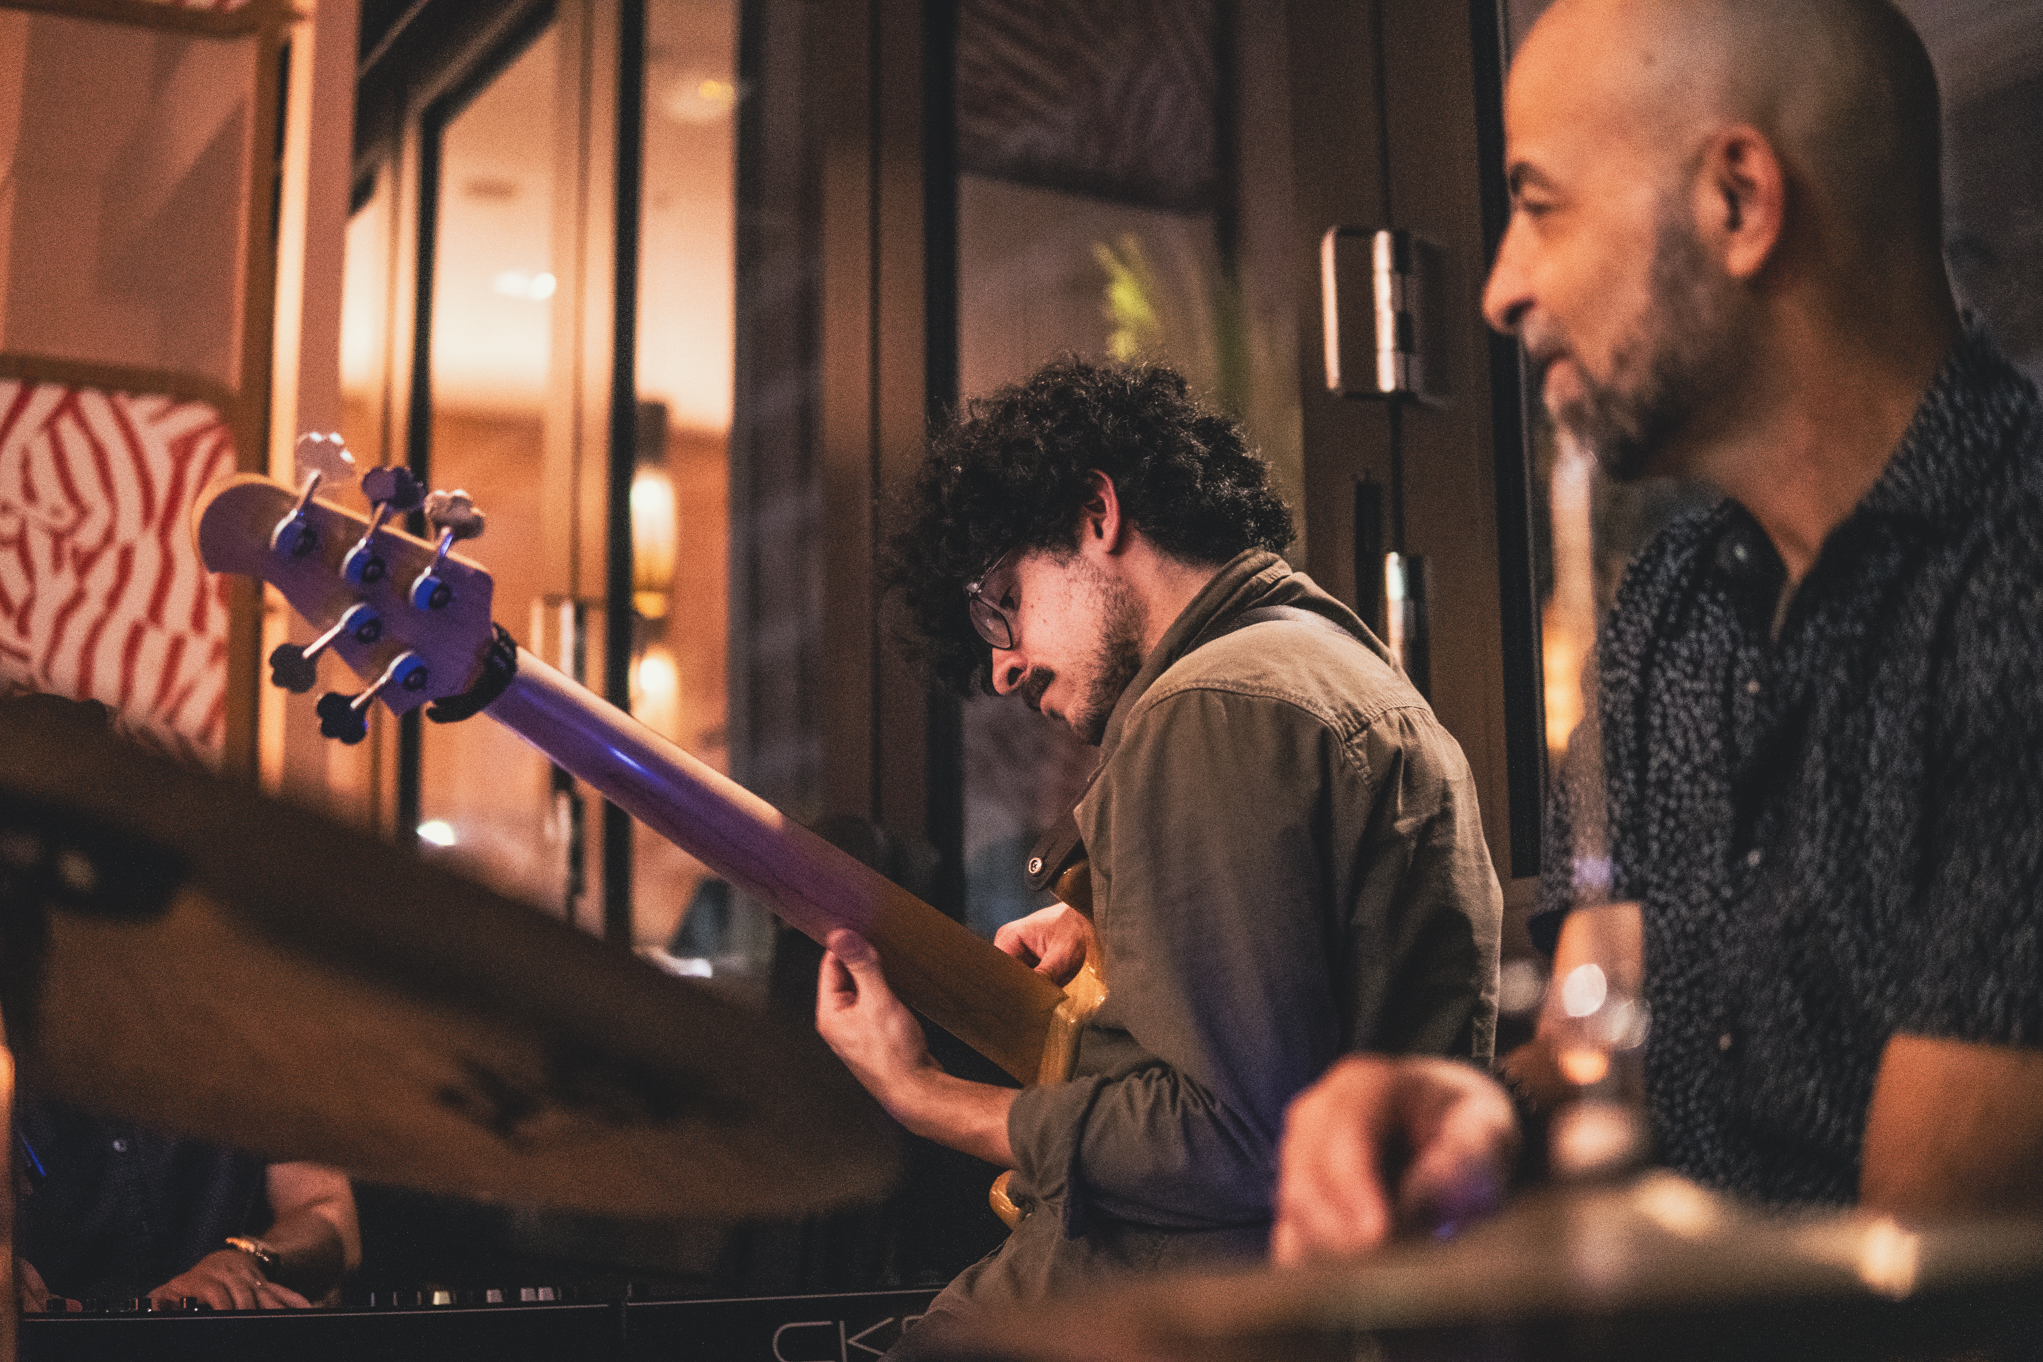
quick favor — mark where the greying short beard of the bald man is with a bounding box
[1540,204,1737,482]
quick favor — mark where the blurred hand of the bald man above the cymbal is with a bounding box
[1271,1054,1518,1264]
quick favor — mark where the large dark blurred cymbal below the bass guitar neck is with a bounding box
[0,704,895,1219]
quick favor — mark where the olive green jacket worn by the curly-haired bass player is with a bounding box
[909,551,1502,1342]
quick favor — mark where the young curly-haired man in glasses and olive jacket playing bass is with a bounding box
[817,359,1502,1356]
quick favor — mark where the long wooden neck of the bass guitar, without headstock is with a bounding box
[482,647,1064,1082]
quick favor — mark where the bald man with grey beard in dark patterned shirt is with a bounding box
[1273,0,2043,1262]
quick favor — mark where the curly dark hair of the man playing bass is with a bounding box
[887,355,1291,694]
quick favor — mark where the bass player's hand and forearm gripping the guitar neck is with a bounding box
[815,927,1015,1168]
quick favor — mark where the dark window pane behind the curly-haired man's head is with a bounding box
[956,0,1303,935]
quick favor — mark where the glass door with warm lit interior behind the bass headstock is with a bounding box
[339,0,770,976]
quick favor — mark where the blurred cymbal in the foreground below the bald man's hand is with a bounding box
[960,1172,2043,1362]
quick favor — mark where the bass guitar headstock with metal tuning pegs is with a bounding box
[192,470,494,741]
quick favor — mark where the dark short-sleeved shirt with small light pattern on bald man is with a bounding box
[1560,333,2043,1203]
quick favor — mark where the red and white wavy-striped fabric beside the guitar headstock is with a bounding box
[0,380,235,762]
